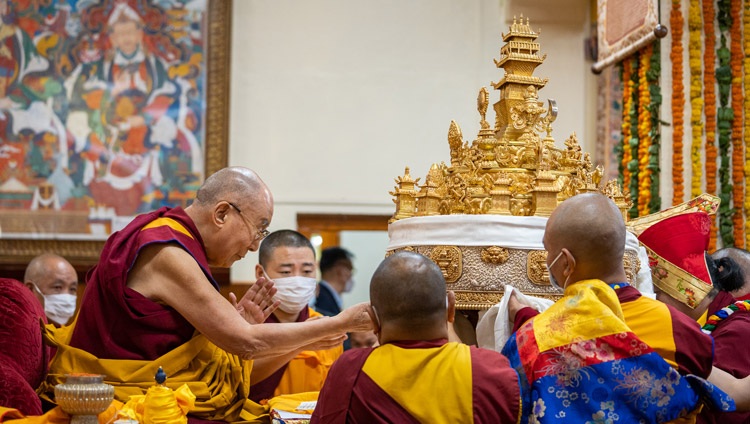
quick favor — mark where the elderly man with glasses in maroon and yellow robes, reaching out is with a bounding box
[43,167,372,422]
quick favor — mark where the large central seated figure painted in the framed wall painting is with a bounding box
[68,2,201,216]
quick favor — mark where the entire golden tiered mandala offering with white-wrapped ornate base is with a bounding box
[388,17,648,309]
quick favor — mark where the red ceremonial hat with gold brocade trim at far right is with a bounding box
[638,211,713,309]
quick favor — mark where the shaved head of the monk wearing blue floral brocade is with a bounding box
[544,193,625,278]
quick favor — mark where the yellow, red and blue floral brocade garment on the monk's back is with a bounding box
[503,280,734,424]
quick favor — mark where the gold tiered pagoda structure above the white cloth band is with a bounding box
[390,17,629,221]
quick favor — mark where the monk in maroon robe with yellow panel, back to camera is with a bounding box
[311,252,520,424]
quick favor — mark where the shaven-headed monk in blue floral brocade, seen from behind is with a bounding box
[503,194,734,423]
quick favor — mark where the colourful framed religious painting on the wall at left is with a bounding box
[0,0,231,263]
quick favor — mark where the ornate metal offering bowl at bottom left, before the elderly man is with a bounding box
[55,374,115,424]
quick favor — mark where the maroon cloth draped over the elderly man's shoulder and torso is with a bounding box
[70,208,219,360]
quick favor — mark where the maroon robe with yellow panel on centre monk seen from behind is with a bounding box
[311,339,520,424]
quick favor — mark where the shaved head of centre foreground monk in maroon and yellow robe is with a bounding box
[370,252,446,329]
